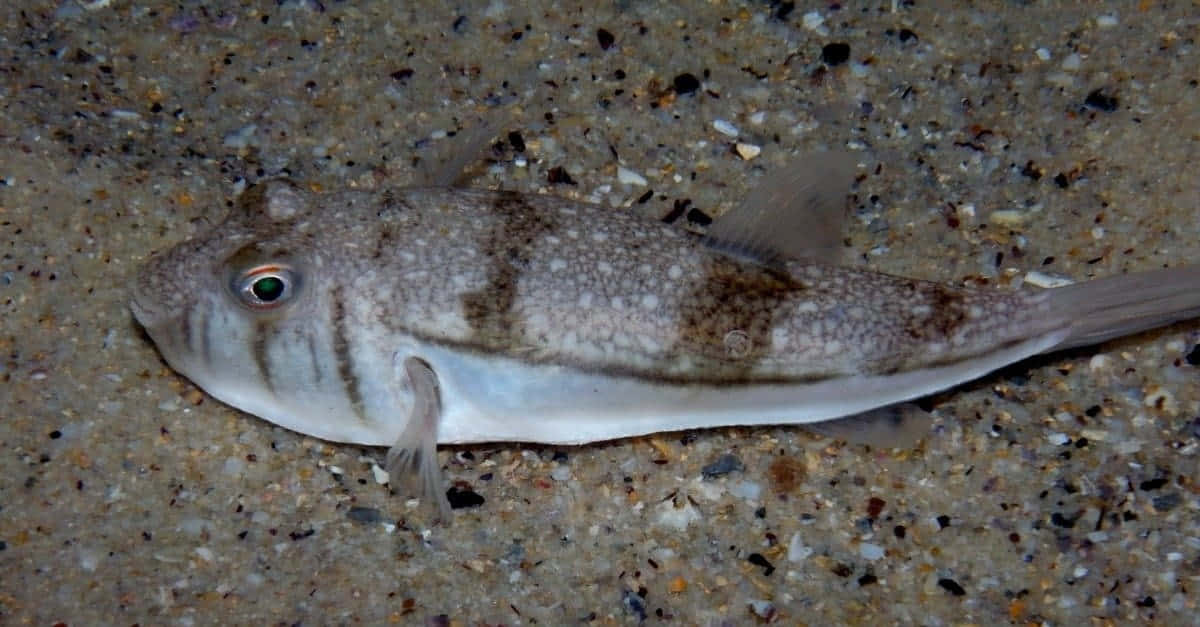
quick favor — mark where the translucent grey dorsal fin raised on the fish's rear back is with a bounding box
[704,151,854,265]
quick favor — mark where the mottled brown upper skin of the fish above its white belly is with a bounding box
[139,181,1061,399]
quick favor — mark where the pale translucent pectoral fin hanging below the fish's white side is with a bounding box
[386,357,450,521]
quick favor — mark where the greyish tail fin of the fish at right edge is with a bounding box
[1046,265,1200,351]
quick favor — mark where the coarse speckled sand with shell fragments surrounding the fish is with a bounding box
[0,0,1200,625]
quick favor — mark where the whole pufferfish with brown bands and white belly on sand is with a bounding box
[130,151,1200,514]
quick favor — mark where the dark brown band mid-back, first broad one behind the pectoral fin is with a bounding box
[462,191,558,345]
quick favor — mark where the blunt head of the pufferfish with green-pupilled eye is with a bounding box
[130,180,376,440]
